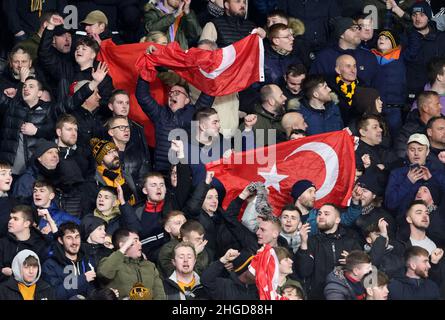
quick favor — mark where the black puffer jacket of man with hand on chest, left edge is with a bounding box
[0,93,55,165]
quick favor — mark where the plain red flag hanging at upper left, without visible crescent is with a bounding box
[98,39,167,147]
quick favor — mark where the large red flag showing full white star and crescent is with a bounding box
[206,130,355,216]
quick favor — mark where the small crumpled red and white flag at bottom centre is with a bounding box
[249,244,288,300]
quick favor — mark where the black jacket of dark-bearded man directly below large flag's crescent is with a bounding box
[294,226,361,299]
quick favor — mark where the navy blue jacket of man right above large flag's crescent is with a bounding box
[300,100,344,135]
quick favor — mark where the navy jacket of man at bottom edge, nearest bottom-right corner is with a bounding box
[388,276,440,300]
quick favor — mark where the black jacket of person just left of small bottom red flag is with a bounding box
[201,260,259,300]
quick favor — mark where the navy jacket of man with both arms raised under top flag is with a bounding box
[136,79,214,171]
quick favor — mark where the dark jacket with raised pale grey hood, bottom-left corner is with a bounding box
[0,250,55,300]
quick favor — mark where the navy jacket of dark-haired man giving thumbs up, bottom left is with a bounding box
[42,242,95,300]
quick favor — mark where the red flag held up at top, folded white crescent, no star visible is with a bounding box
[137,34,264,96]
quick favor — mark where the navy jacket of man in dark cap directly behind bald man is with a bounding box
[309,44,378,87]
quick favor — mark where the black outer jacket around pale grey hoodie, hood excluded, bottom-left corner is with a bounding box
[0,278,56,300]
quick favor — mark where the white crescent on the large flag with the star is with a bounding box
[284,142,339,200]
